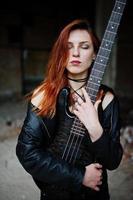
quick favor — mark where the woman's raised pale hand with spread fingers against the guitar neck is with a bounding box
[73,88,103,142]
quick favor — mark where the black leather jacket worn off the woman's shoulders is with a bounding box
[16,87,123,199]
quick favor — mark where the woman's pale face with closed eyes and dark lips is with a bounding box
[66,29,95,78]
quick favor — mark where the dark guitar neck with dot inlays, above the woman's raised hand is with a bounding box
[86,0,126,103]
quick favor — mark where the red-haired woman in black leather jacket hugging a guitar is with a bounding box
[16,20,123,200]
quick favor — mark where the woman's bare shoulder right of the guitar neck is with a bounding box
[100,85,115,110]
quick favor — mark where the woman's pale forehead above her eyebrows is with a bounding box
[68,29,91,42]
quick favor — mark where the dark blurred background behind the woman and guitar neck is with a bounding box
[0,0,133,124]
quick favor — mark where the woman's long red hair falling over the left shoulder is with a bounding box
[31,19,100,117]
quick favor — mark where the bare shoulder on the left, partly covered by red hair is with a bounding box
[31,85,44,108]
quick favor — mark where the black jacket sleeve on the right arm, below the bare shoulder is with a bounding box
[91,97,123,170]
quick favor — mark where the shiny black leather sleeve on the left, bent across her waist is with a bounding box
[16,103,85,188]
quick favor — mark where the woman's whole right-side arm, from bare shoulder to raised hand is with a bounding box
[74,89,123,170]
